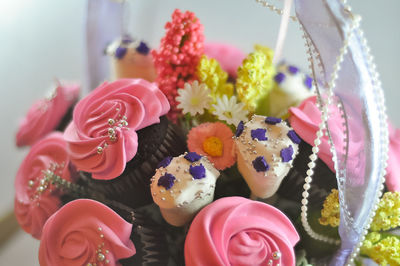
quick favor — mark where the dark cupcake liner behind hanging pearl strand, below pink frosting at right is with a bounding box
[277,141,337,208]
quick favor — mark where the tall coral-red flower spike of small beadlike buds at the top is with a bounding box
[152,9,204,120]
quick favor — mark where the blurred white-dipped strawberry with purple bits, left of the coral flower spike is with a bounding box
[106,36,156,82]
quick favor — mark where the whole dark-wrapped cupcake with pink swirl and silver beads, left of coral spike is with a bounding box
[64,79,186,208]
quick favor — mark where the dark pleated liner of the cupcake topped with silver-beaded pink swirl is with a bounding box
[86,117,186,208]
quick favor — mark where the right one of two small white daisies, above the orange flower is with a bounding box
[212,95,249,126]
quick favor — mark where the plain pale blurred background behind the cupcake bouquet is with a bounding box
[0,0,400,265]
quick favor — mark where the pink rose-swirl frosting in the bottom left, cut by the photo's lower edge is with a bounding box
[39,199,136,266]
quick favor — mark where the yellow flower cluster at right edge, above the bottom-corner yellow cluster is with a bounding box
[371,192,400,231]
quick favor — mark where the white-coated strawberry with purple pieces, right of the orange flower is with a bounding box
[235,115,300,199]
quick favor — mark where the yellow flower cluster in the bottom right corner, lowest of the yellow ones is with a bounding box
[360,232,400,265]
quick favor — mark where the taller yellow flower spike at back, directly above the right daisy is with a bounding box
[236,46,276,112]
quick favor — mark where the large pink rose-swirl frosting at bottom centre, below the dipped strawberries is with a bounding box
[185,197,299,266]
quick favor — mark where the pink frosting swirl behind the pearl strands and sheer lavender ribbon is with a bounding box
[289,96,364,185]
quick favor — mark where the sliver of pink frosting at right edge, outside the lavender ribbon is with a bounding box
[386,123,400,191]
